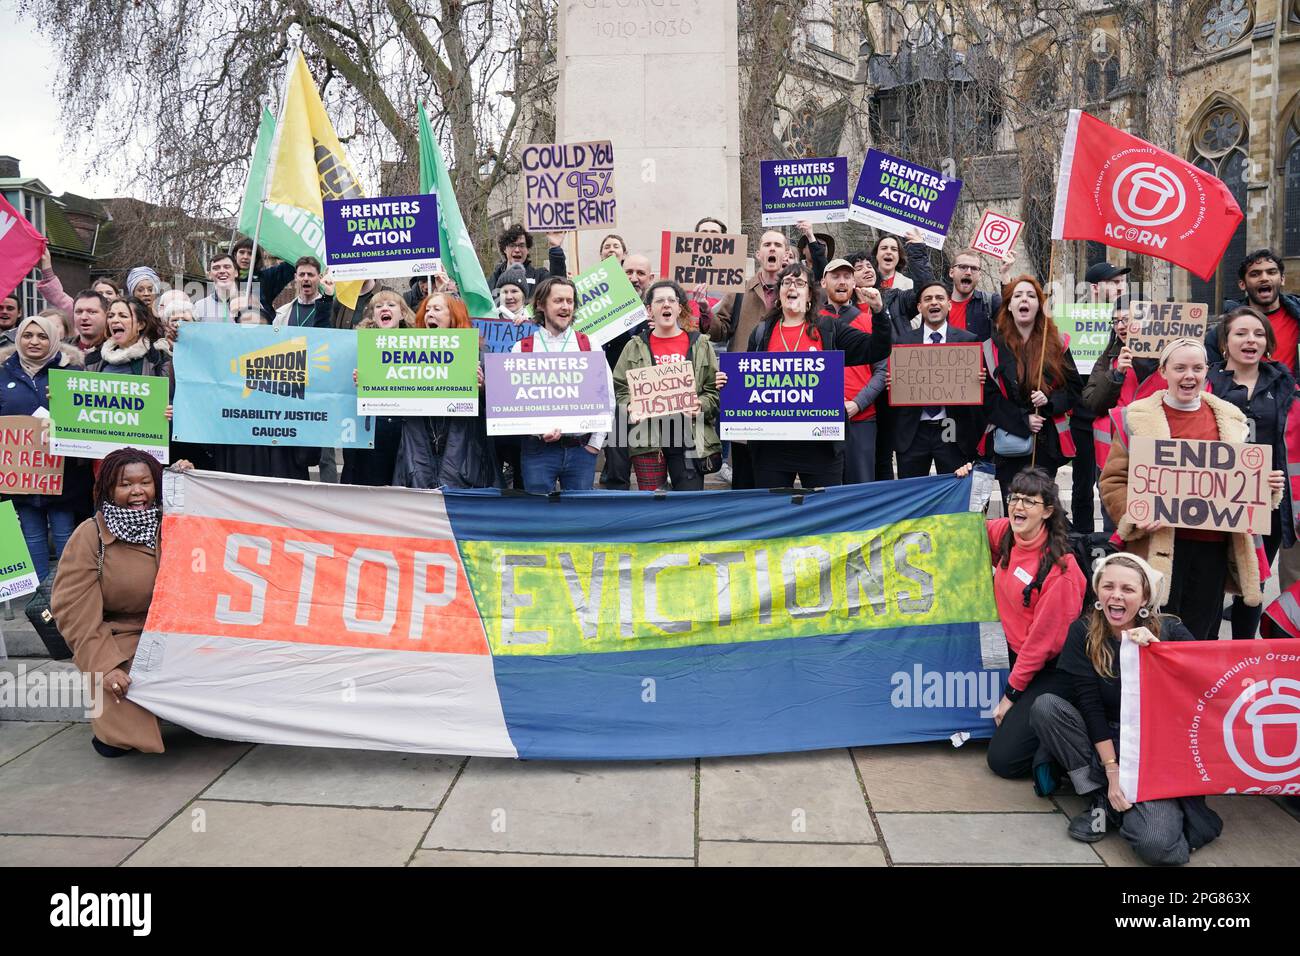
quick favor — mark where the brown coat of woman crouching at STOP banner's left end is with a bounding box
[49,514,163,753]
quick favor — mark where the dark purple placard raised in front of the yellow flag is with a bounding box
[325,193,442,280]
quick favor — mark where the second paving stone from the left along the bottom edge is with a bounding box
[126,800,433,866]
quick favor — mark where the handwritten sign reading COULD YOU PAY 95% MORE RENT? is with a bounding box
[520,139,616,233]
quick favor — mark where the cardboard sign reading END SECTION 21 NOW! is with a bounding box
[1127,436,1273,535]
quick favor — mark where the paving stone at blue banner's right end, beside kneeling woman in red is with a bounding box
[853,740,1056,813]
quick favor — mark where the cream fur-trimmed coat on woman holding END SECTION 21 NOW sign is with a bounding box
[1099,389,1282,607]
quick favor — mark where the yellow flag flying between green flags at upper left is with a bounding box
[265,51,364,308]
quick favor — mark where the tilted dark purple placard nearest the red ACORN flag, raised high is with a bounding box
[849,150,962,248]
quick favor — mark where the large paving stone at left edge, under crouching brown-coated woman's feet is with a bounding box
[0,726,248,838]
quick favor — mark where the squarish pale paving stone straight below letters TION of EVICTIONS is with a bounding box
[699,750,876,843]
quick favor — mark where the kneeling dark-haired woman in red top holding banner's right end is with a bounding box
[957,464,1086,779]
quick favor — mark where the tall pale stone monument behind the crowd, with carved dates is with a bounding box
[555,0,740,272]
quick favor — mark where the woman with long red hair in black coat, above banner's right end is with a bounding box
[985,276,1083,499]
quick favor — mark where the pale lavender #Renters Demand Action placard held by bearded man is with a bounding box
[484,349,614,434]
